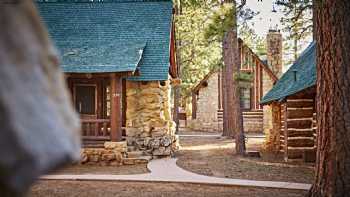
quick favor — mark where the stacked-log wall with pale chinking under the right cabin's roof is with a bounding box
[280,99,315,162]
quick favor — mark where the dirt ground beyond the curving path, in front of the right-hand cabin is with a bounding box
[176,137,314,183]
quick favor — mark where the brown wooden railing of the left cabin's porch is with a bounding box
[81,119,111,140]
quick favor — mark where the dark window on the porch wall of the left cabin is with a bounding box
[75,85,96,115]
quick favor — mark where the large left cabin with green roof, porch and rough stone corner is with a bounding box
[36,0,178,158]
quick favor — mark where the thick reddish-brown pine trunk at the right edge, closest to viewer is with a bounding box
[309,0,350,197]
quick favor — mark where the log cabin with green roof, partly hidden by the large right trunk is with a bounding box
[261,42,316,162]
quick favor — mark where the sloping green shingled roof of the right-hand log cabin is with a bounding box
[260,42,316,104]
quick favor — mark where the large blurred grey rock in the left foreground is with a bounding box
[0,0,80,196]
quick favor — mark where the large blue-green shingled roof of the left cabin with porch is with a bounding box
[37,0,172,81]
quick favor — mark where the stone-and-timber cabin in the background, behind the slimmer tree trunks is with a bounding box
[188,30,282,133]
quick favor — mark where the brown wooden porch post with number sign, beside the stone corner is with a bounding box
[110,73,122,142]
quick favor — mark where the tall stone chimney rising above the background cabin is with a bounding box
[266,29,283,78]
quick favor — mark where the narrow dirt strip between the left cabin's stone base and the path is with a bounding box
[52,164,149,175]
